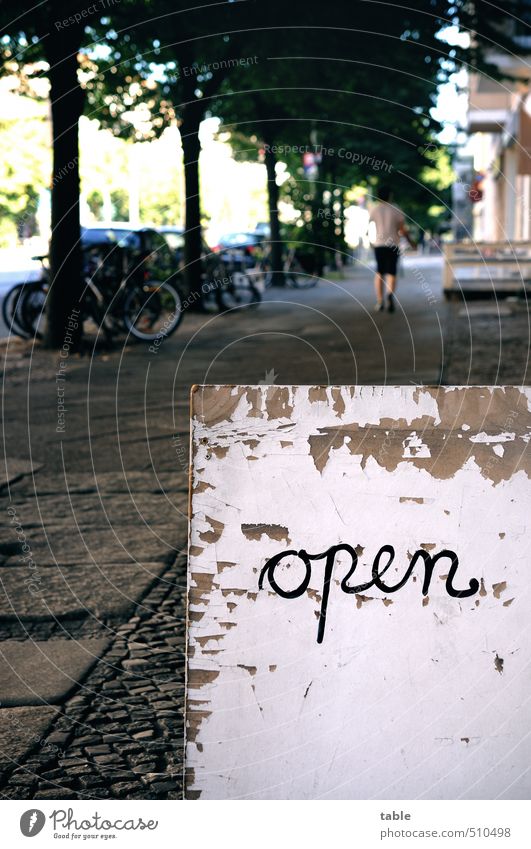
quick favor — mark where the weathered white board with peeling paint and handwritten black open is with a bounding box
[186,386,531,799]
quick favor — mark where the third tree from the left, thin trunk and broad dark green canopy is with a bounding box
[215,0,462,274]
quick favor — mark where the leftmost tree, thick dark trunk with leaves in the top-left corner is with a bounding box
[0,0,137,348]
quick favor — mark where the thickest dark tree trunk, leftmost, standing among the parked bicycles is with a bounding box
[44,26,83,348]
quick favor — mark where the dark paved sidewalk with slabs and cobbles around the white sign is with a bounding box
[0,258,529,798]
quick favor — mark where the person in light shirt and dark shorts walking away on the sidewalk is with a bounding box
[369,186,415,312]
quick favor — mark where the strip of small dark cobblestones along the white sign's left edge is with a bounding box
[2,558,186,799]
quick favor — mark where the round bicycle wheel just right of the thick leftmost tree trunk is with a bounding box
[123,280,183,342]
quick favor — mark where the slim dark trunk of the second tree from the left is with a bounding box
[180,102,203,309]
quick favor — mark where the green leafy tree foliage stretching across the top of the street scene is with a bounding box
[0,0,530,252]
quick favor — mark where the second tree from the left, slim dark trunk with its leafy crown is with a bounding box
[89,0,258,306]
